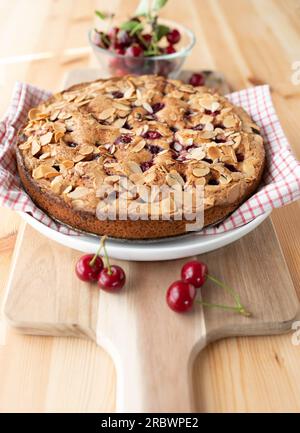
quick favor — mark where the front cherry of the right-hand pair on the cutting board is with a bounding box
[166,281,196,313]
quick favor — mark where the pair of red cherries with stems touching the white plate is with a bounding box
[75,238,126,292]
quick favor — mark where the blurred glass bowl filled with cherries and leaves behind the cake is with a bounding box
[89,2,195,78]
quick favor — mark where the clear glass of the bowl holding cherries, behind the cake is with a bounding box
[89,20,196,78]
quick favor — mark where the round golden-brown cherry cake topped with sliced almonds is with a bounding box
[17,75,265,239]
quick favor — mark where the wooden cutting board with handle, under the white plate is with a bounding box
[4,219,298,412]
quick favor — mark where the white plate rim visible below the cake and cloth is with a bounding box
[20,212,271,261]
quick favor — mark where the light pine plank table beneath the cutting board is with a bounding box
[0,0,300,412]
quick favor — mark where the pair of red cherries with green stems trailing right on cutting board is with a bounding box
[166,260,250,317]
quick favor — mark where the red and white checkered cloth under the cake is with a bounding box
[0,83,300,236]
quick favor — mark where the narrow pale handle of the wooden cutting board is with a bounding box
[101,330,205,413]
